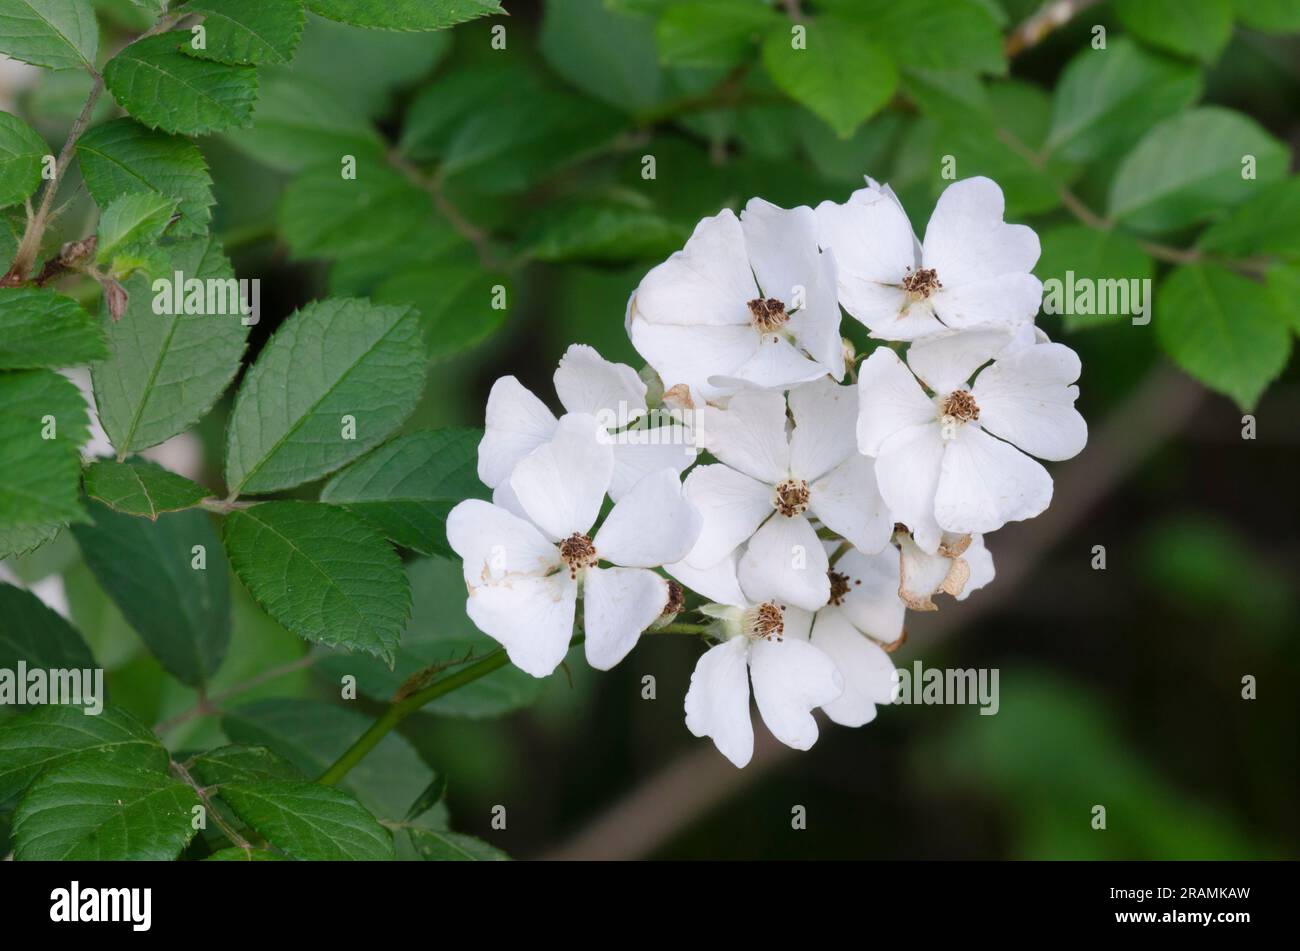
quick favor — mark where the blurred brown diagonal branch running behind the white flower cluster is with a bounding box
[543,364,1208,859]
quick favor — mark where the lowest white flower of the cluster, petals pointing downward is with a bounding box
[685,602,844,767]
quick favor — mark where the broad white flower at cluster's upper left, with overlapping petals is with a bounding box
[627,199,844,404]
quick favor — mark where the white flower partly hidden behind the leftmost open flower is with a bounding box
[478,344,696,511]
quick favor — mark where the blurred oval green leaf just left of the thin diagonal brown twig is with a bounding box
[278,156,433,257]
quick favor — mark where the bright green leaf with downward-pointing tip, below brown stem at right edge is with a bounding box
[1154,265,1291,412]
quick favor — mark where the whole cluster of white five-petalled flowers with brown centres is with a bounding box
[447,178,1087,767]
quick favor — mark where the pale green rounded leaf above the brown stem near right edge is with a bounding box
[1108,107,1290,233]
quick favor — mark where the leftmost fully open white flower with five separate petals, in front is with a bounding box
[447,413,699,677]
